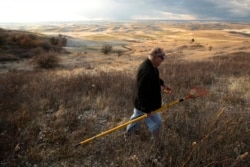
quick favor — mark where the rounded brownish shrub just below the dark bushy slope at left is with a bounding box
[33,52,59,69]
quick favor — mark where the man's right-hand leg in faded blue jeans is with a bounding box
[145,113,162,134]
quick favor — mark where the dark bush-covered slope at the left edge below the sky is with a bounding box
[0,29,66,61]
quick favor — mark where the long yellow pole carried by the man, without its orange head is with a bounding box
[75,96,188,146]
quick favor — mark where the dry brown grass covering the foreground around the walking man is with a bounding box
[0,52,250,167]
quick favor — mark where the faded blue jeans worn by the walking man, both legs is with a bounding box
[126,108,162,134]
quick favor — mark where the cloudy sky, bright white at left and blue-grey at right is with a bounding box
[0,0,250,23]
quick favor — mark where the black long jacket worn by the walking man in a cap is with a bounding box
[134,59,164,113]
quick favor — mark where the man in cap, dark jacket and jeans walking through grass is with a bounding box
[125,48,172,140]
